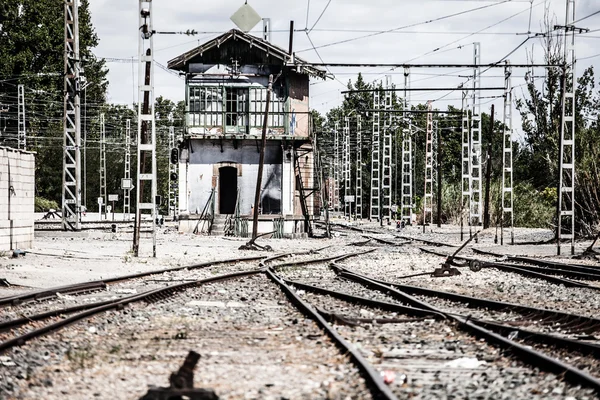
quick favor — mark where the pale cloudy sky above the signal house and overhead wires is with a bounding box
[90,0,600,141]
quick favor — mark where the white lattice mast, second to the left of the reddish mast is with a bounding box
[381,75,393,223]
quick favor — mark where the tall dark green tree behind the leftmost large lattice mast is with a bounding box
[0,0,108,202]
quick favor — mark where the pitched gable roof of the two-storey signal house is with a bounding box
[167,29,327,78]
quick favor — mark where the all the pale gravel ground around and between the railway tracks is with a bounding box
[0,224,600,400]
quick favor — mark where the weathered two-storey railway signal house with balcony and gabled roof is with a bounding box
[168,29,325,233]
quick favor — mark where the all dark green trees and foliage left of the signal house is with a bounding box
[0,0,185,213]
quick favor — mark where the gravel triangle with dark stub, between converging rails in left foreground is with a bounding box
[0,275,370,399]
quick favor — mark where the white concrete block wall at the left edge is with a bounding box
[0,147,35,251]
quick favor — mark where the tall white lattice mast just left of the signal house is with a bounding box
[133,0,156,257]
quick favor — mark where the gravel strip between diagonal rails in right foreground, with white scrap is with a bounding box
[282,268,594,399]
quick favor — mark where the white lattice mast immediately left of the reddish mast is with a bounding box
[402,68,413,225]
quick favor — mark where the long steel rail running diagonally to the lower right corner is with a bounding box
[338,267,600,392]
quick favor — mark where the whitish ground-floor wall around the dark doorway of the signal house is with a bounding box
[180,139,292,214]
